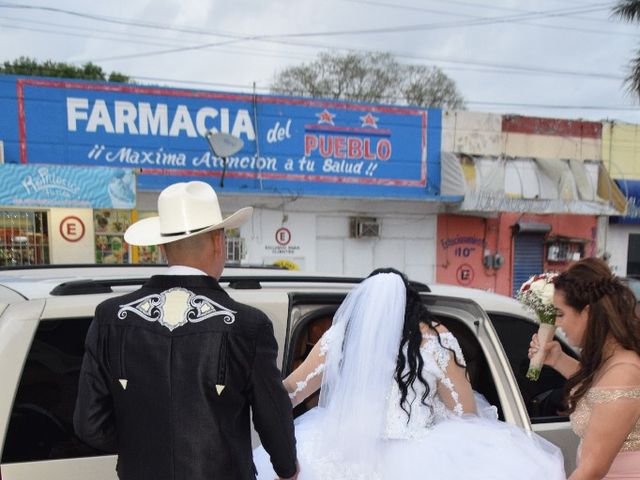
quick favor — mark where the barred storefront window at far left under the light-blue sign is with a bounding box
[0,210,49,267]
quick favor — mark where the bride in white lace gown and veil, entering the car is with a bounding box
[254,268,565,480]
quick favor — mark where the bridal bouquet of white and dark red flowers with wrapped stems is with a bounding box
[518,273,558,381]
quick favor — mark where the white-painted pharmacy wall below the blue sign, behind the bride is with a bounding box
[138,192,442,282]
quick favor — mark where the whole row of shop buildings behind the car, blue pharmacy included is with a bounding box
[0,76,640,288]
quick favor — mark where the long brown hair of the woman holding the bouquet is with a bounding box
[555,258,640,413]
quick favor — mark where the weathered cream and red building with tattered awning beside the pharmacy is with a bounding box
[436,112,625,295]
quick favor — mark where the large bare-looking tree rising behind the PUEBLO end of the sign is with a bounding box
[271,52,464,109]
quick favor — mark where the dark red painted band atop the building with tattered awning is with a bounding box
[502,115,602,138]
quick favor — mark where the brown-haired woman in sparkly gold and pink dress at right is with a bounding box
[529,258,640,480]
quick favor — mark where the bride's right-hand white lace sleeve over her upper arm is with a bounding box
[427,332,476,416]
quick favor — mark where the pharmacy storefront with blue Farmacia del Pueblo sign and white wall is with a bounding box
[0,73,450,281]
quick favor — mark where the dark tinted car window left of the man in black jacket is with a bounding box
[2,318,102,463]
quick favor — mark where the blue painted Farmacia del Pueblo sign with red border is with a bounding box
[0,77,441,199]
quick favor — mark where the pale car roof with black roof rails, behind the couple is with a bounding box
[0,265,535,319]
